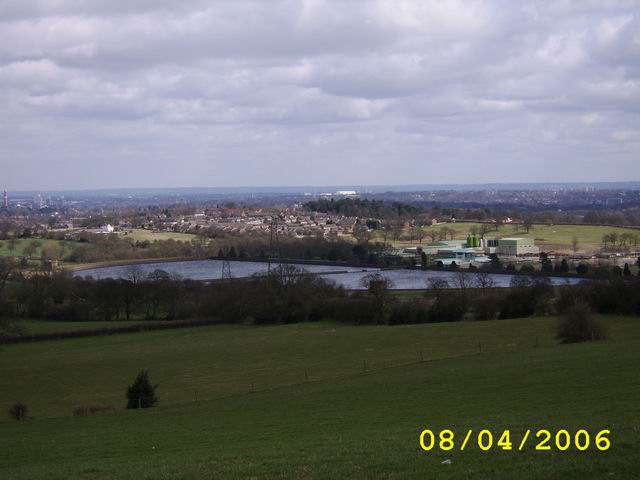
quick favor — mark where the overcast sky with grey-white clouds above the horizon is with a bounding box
[0,0,640,190]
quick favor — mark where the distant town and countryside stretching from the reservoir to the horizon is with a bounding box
[0,186,640,271]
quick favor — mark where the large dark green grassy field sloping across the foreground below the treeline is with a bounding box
[0,317,640,480]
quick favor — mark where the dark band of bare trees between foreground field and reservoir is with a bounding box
[0,256,640,334]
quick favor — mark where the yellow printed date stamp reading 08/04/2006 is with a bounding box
[419,428,611,452]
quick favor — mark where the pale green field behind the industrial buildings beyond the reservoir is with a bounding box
[394,223,640,253]
